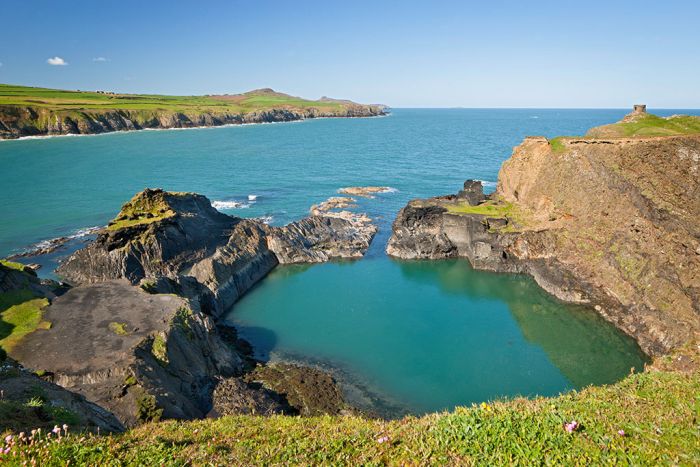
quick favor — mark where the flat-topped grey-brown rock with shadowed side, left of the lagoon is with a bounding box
[12,280,242,426]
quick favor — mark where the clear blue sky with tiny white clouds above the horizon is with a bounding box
[0,0,700,108]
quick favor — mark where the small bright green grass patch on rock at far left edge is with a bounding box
[0,290,51,353]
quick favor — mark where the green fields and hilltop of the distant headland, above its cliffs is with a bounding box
[0,84,344,113]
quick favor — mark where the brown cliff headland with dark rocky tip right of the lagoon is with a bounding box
[387,110,700,356]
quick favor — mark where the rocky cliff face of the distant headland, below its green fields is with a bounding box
[0,104,385,139]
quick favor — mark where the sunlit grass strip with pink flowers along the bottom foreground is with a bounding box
[6,371,700,465]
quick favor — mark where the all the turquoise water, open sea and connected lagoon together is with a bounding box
[0,109,698,416]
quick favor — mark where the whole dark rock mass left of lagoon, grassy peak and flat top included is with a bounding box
[3,189,376,427]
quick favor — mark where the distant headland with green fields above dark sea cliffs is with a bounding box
[0,84,385,139]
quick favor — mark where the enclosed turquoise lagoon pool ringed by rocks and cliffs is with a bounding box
[230,257,643,416]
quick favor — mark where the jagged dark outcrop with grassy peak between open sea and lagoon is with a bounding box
[57,190,376,316]
